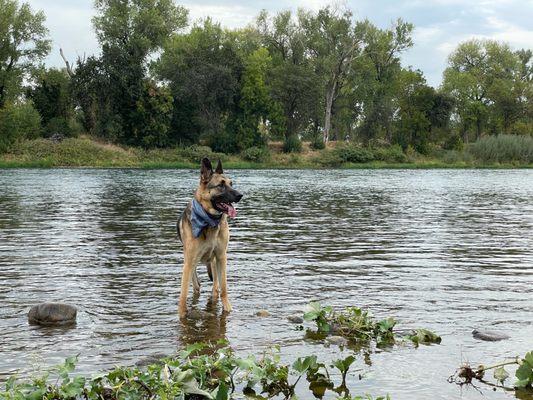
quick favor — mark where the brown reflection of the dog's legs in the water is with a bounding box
[177,296,227,345]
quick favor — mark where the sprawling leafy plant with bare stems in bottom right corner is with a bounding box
[448,351,533,391]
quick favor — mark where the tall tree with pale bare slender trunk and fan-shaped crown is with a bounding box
[298,6,363,143]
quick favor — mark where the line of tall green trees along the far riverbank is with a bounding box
[0,0,533,154]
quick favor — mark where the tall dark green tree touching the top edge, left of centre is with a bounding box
[76,0,187,146]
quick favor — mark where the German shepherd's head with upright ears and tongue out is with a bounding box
[196,158,242,218]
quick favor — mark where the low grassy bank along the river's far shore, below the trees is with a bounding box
[0,136,533,169]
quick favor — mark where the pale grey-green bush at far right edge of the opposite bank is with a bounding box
[467,135,533,164]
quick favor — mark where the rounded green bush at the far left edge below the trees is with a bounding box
[0,103,41,152]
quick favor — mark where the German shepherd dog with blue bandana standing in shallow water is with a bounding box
[177,158,242,318]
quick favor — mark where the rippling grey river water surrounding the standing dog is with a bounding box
[0,169,533,400]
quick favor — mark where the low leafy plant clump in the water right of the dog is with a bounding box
[304,302,441,345]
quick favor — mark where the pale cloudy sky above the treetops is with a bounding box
[26,0,533,87]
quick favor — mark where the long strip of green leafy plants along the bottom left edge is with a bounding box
[0,343,388,400]
